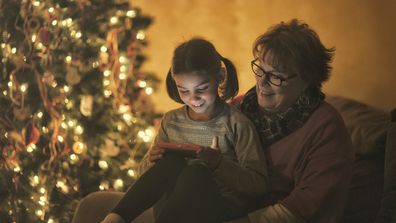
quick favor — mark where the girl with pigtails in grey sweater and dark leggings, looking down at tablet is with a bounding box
[103,39,268,223]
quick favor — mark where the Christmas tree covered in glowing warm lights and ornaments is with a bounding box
[0,0,159,222]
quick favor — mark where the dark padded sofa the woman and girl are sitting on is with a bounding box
[73,96,396,223]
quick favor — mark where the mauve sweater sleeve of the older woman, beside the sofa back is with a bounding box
[280,111,353,223]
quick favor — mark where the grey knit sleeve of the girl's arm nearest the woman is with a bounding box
[214,113,269,197]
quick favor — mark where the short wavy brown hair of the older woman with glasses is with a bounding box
[253,19,335,88]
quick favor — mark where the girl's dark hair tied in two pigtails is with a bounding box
[166,38,239,104]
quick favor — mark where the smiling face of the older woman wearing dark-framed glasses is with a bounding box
[256,56,308,113]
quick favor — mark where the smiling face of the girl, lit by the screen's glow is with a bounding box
[173,72,222,121]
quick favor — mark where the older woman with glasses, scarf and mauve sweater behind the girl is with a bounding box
[74,20,353,223]
